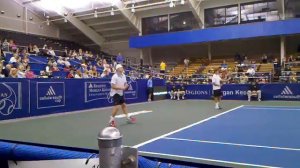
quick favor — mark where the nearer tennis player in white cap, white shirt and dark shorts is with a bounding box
[109,64,136,127]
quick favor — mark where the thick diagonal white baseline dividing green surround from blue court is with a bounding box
[133,105,244,148]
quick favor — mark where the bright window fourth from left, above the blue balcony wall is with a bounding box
[241,0,279,23]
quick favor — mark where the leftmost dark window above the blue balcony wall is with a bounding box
[142,15,168,35]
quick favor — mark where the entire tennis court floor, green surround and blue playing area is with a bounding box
[0,100,300,167]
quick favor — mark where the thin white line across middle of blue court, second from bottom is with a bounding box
[162,137,300,151]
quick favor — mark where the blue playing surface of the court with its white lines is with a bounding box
[135,106,300,168]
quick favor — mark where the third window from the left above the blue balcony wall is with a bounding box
[205,5,238,27]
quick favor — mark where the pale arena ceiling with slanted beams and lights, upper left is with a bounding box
[16,0,207,45]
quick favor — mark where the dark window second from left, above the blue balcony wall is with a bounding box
[170,12,200,32]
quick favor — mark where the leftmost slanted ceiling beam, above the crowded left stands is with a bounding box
[65,11,105,46]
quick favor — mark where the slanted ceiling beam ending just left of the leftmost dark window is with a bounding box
[115,0,142,33]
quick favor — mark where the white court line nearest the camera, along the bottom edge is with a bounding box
[139,151,279,168]
